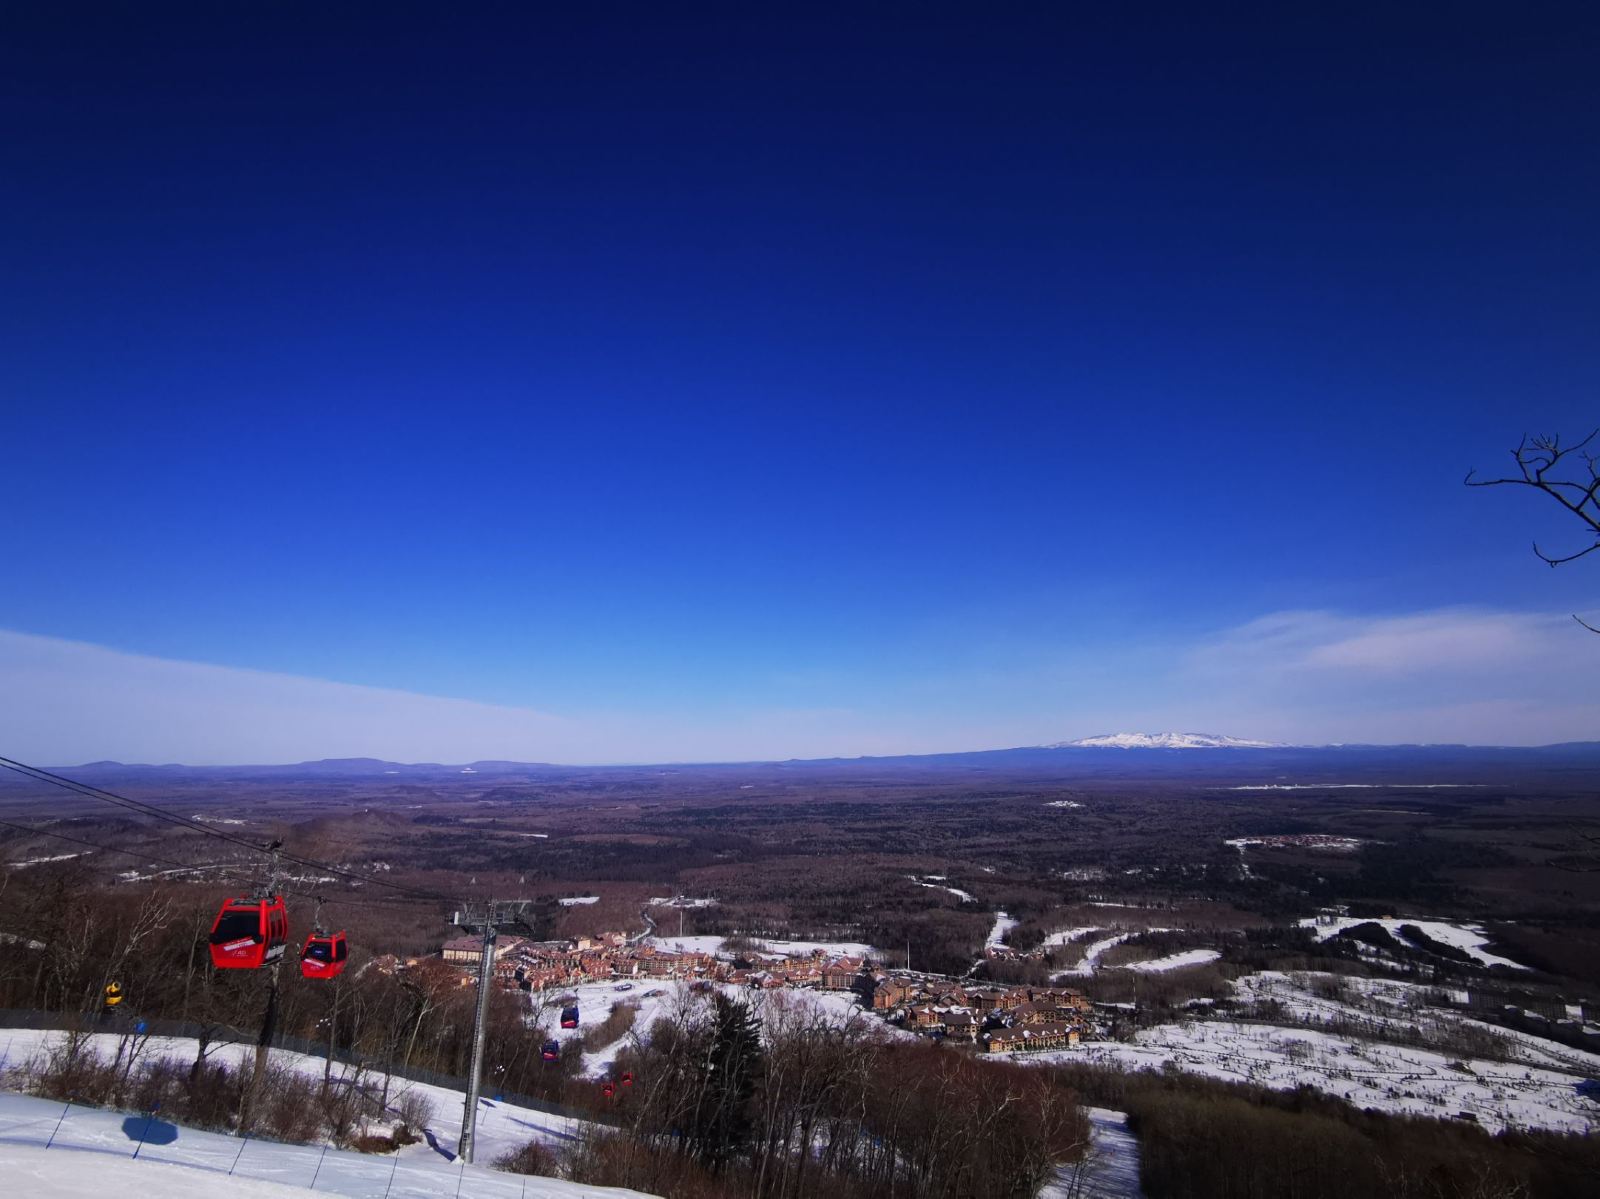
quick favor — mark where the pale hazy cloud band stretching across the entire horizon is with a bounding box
[0,608,1600,764]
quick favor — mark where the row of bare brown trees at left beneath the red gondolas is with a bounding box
[0,866,587,1101]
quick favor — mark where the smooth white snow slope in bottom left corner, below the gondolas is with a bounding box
[0,1029,656,1199]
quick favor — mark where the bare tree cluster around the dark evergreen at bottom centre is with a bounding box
[524,992,1088,1199]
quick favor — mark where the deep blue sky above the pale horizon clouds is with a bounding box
[0,3,1600,760]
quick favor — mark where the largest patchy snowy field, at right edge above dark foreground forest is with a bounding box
[1029,972,1600,1133]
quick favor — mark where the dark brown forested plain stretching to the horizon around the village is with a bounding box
[0,759,1600,1197]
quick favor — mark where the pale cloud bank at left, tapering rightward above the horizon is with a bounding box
[0,629,931,765]
